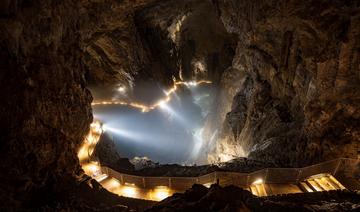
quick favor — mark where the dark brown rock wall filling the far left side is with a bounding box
[0,0,154,211]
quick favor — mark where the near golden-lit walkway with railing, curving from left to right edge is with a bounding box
[78,122,360,201]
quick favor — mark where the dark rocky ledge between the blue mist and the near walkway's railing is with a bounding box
[92,133,277,177]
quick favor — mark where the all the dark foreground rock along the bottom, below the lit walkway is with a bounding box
[37,180,360,212]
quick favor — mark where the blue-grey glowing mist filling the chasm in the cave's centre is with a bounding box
[92,83,215,165]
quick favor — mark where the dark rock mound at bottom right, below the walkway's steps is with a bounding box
[146,184,360,211]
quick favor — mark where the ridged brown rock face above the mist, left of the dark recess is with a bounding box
[82,0,153,87]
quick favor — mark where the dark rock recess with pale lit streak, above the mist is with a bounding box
[135,0,236,84]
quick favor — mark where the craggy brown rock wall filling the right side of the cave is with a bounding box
[210,0,360,165]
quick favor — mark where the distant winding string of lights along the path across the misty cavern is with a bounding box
[91,80,212,113]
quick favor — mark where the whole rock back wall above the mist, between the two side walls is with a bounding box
[84,0,236,90]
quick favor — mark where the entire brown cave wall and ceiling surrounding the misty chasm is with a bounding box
[0,0,360,208]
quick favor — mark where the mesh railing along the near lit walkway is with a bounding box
[101,158,360,191]
